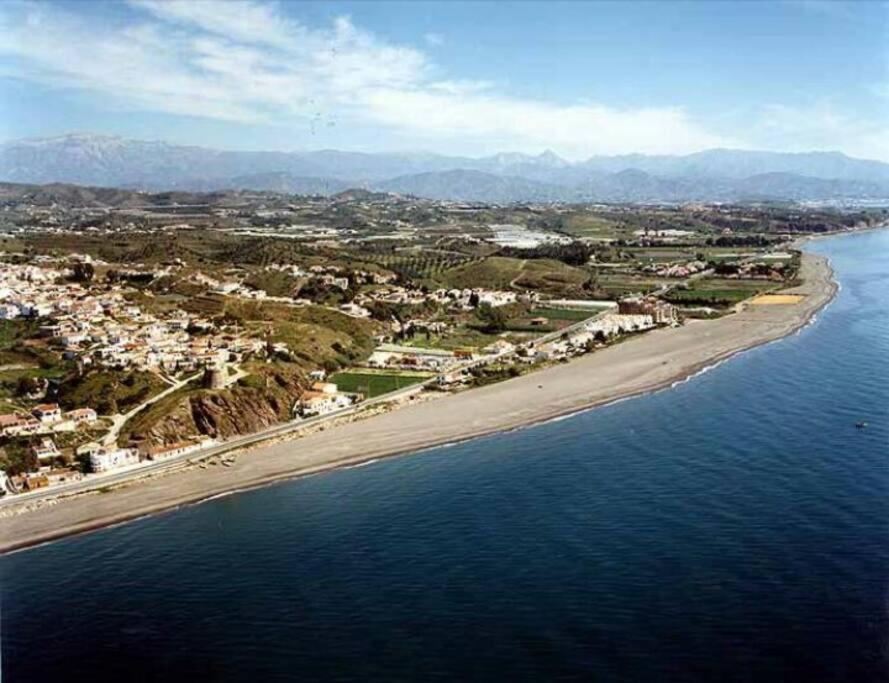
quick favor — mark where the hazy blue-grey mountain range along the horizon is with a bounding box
[0,134,889,202]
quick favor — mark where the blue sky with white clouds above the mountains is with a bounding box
[0,0,889,161]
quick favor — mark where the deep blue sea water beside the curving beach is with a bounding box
[0,232,889,683]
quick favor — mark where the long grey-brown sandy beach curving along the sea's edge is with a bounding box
[0,254,837,553]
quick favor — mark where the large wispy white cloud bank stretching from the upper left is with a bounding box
[0,0,739,158]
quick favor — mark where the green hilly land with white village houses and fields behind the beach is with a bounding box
[0,183,876,496]
